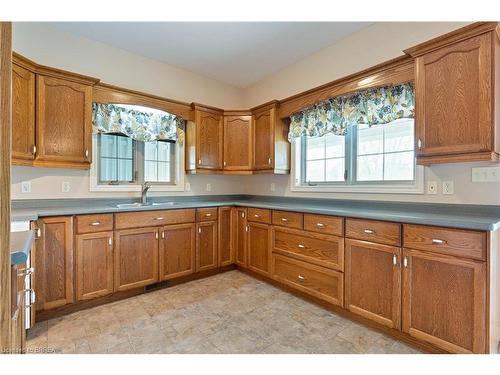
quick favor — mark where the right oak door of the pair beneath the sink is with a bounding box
[160,223,196,280]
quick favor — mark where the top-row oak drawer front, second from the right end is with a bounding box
[345,219,401,246]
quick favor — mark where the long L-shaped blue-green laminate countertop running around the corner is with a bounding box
[11,195,500,230]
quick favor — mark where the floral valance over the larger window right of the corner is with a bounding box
[288,82,415,141]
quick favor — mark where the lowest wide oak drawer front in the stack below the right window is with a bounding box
[273,254,344,306]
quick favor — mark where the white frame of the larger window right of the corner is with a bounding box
[290,122,424,194]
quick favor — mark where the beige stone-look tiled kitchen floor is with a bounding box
[27,271,418,353]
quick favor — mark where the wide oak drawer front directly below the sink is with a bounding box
[115,209,195,229]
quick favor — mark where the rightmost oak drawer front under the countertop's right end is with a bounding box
[403,224,486,260]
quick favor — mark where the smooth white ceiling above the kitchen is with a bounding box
[50,22,370,88]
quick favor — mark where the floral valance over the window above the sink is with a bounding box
[92,103,184,142]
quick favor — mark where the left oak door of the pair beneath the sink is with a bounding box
[114,228,158,291]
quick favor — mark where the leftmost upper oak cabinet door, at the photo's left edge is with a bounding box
[12,64,36,165]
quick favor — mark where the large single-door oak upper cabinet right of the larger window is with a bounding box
[407,25,499,164]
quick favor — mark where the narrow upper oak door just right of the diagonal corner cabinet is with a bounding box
[253,109,274,170]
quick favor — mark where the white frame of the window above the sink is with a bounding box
[90,134,185,192]
